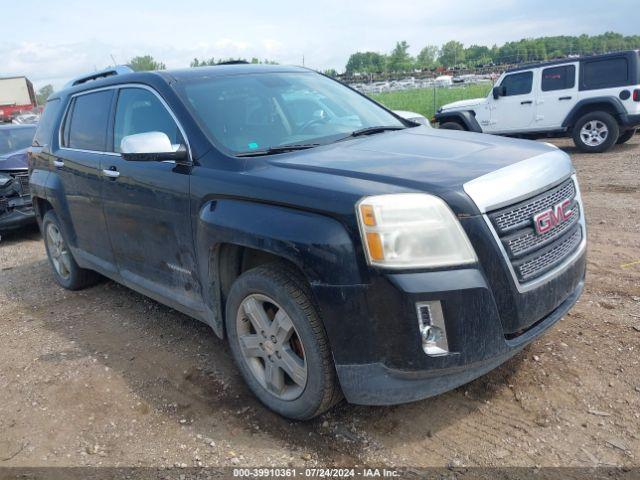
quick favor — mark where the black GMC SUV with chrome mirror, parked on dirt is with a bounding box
[30,65,586,419]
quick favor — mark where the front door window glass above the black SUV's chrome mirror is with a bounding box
[113,88,184,152]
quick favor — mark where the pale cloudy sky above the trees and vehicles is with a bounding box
[0,0,640,89]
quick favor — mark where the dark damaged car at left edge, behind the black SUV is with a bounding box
[0,125,36,232]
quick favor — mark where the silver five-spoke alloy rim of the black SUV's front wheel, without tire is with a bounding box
[236,293,307,401]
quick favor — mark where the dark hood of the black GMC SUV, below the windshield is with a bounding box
[268,127,566,214]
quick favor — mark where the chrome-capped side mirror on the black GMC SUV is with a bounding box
[120,132,189,163]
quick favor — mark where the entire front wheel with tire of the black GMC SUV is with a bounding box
[225,263,342,420]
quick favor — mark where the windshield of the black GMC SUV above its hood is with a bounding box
[178,72,404,154]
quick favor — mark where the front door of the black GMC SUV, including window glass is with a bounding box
[102,87,200,307]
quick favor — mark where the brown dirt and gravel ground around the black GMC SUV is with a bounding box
[0,137,640,468]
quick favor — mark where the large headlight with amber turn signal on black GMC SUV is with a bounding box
[356,193,477,269]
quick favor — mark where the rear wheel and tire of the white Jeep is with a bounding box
[573,111,620,153]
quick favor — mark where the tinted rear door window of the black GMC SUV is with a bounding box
[67,90,113,152]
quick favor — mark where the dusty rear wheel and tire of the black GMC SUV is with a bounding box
[42,210,100,290]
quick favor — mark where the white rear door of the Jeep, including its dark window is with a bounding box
[535,63,578,130]
